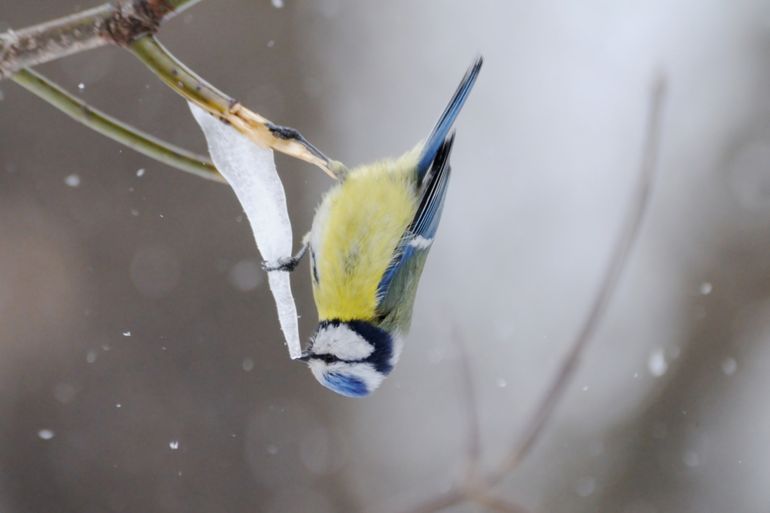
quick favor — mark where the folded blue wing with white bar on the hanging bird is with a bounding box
[377,134,454,304]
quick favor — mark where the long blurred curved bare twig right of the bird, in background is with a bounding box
[392,77,666,513]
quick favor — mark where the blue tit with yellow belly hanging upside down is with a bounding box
[268,56,483,397]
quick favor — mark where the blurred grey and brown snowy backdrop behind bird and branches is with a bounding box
[0,0,770,513]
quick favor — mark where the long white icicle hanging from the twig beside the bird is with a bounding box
[190,103,302,358]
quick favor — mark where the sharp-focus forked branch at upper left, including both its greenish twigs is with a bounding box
[0,0,346,179]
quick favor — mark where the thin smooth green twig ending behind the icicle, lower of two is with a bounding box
[12,69,224,182]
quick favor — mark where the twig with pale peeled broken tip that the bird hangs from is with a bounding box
[129,36,345,178]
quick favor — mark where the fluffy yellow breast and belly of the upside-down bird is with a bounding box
[310,151,417,321]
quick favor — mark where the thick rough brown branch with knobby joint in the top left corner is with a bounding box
[0,0,200,80]
